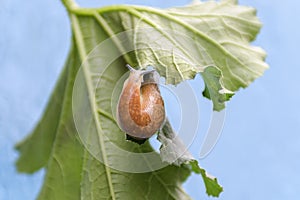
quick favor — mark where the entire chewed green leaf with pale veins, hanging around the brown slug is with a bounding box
[16,0,267,200]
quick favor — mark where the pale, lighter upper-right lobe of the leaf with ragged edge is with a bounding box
[89,1,268,111]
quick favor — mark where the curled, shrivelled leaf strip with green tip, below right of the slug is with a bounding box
[158,120,223,197]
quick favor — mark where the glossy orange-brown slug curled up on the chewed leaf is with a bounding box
[116,64,165,143]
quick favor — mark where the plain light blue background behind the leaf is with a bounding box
[0,0,300,200]
